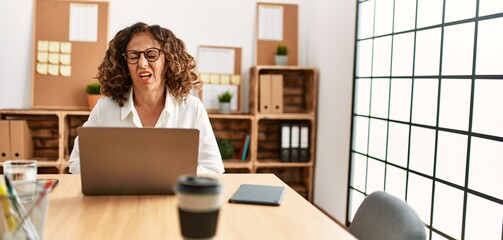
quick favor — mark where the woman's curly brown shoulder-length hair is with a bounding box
[96,22,199,107]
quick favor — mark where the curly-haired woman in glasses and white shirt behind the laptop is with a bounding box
[69,22,224,173]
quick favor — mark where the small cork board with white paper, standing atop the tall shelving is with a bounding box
[255,2,298,66]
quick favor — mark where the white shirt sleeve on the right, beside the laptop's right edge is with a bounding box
[197,101,225,174]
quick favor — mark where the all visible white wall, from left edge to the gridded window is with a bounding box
[0,0,355,222]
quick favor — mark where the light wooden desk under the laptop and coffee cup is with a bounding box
[38,174,356,240]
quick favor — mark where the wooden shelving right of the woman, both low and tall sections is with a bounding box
[210,66,318,201]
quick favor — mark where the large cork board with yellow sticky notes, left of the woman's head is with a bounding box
[32,0,109,110]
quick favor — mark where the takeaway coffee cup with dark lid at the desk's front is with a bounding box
[175,175,221,239]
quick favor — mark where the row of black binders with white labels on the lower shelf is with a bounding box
[280,123,309,162]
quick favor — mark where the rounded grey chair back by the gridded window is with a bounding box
[349,191,426,240]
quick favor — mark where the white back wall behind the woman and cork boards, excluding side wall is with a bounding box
[0,0,307,109]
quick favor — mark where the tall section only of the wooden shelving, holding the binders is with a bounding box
[250,66,318,201]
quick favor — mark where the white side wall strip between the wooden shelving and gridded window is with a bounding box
[307,0,356,223]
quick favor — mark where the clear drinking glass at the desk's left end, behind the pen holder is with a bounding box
[3,160,37,201]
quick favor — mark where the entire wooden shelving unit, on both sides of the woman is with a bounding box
[0,66,318,201]
